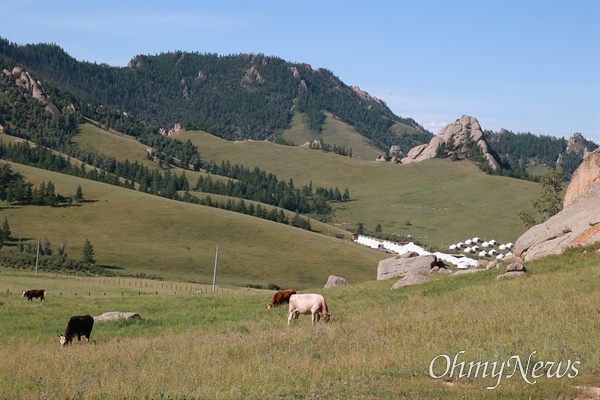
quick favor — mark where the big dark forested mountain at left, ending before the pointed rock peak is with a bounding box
[0,39,431,150]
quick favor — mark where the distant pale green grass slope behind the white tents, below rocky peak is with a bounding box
[176,131,539,248]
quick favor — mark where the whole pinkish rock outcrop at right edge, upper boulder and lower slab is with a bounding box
[514,149,600,261]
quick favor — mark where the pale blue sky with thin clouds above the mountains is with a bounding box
[0,0,600,144]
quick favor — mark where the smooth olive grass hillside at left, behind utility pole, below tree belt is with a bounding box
[0,163,384,288]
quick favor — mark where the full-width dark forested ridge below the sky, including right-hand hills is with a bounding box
[0,38,597,180]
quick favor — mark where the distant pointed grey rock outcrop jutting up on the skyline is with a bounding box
[402,115,498,169]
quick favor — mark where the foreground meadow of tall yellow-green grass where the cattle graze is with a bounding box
[0,247,600,399]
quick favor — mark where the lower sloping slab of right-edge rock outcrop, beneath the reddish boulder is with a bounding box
[514,173,600,261]
